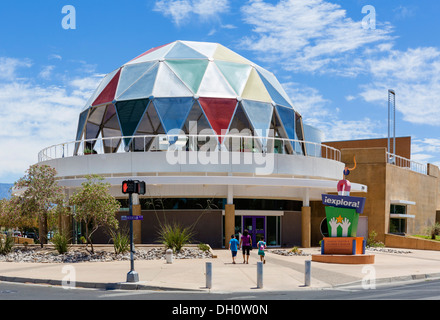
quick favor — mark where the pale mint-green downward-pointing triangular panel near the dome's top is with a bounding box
[166,60,209,94]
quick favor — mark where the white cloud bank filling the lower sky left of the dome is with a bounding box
[0,57,101,183]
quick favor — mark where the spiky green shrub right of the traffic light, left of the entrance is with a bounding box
[159,223,194,252]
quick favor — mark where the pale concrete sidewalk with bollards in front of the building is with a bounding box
[0,248,440,292]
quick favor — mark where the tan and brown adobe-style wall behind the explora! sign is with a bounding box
[341,148,440,243]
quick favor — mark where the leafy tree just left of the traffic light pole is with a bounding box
[69,175,121,253]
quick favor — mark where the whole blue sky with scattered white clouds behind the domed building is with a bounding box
[0,0,440,183]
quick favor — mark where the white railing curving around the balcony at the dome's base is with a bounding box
[38,134,341,162]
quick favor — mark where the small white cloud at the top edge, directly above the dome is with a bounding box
[153,0,229,25]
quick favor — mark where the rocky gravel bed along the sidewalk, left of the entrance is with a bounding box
[0,248,212,263]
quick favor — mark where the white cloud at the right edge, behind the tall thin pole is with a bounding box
[361,47,440,126]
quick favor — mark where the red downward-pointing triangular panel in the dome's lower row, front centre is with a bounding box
[199,98,237,143]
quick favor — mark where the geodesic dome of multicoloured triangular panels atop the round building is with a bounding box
[76,41,303,153]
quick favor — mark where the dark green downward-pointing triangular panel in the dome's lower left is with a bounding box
[116,99,149,146]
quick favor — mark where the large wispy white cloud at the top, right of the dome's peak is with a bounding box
[242,0,391,75]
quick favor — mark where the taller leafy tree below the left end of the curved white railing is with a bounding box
[12,164,64,247]
